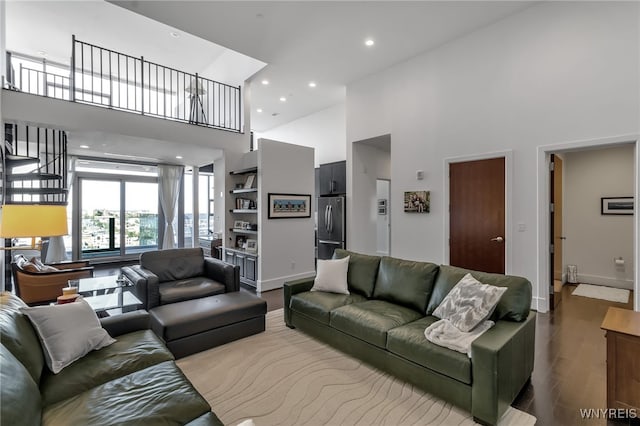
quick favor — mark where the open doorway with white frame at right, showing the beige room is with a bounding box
[536,135,640,312]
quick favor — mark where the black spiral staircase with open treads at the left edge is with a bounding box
[0,123,68,291]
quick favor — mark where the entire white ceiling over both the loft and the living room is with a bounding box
[6,0,534,150]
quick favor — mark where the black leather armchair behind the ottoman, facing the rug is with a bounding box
[122,248,240,310]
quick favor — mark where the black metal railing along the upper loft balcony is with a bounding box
[3,36,242,132]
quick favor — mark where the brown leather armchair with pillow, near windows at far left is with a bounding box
[11,254,93,304]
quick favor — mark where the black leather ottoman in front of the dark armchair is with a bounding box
[149,291,267,358]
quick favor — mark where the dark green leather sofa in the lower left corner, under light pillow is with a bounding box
[0,293,222,426]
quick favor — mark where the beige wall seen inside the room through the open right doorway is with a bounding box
[563,145,635,289]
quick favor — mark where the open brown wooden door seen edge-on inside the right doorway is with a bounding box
[549,154,564,310]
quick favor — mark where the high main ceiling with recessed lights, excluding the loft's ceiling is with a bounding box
[113,0,532,131]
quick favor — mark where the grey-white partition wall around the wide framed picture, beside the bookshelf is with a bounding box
[257,139,315,292]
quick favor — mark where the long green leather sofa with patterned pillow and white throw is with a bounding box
[284,250,535,424]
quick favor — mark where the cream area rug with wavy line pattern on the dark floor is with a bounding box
[178,309,536,426]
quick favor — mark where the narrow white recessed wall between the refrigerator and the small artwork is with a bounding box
[347,141,390,255]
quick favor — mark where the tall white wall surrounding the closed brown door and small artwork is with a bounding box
[347,2,640,307]
